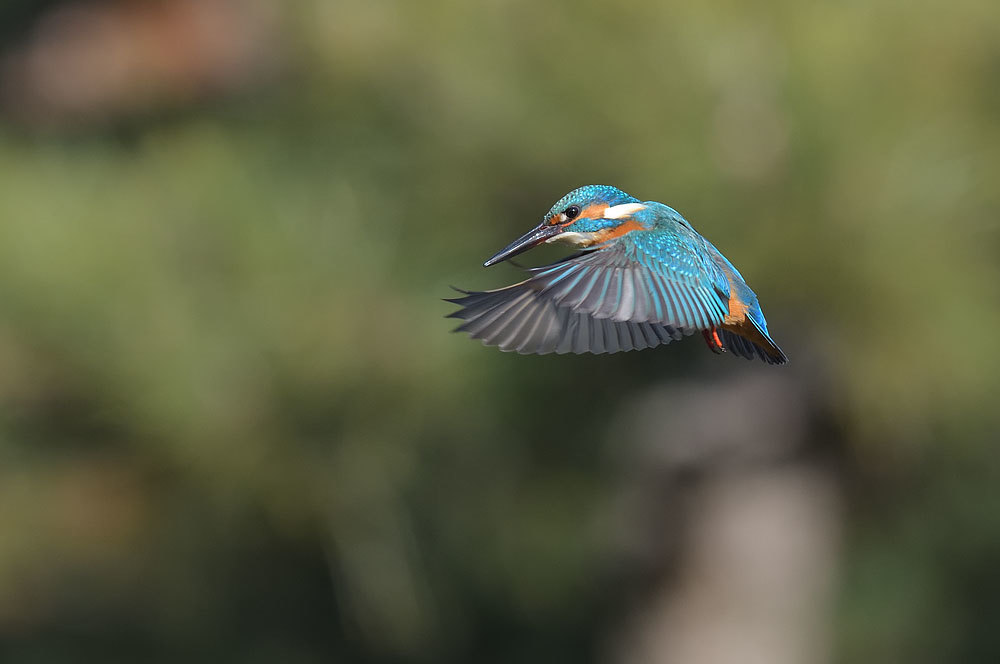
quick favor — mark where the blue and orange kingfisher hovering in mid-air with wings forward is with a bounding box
[447,185,788,364]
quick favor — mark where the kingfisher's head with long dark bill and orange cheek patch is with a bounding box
[483,184,647,267]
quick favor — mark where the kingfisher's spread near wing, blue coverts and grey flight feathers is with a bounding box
[449,232,729,354]
